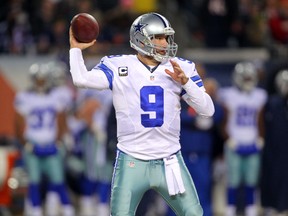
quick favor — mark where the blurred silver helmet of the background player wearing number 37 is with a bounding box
[29,63,51,92]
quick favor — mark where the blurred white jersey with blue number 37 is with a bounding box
[14,91,62,145]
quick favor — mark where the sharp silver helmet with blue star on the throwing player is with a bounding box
[130,13,178,62]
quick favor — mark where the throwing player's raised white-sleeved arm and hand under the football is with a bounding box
[69,28,109,89]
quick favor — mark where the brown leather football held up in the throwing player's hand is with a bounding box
[71,13,99,43]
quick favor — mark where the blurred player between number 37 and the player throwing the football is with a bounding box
[66,89,116,216]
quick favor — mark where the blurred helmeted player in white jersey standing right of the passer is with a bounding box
[219,62,267,216]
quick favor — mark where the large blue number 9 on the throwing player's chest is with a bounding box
[140,86,164,127]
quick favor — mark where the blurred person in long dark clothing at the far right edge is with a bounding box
[261,68,288,216]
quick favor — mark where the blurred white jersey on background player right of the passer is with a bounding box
[219,86,267,145]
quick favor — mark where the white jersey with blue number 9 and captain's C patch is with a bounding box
[92,55,204,160]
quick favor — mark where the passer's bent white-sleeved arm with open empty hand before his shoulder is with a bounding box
[165,60,215,117]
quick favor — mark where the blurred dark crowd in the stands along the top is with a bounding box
[0,0,288,55]
